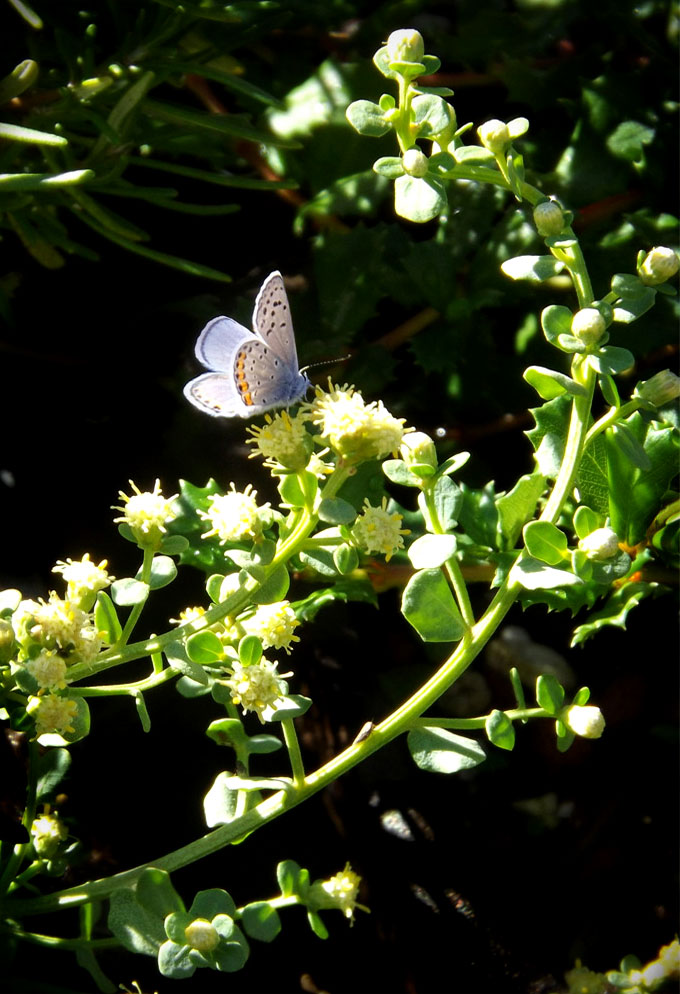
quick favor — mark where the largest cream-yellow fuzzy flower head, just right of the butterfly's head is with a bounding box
[311,381,404,463]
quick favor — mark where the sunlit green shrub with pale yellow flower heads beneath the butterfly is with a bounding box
[0,21,680,989]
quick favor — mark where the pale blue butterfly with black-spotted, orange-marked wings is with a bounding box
[184,272,310,418]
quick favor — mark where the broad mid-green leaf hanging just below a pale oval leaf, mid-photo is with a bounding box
[401,569,465,642]
